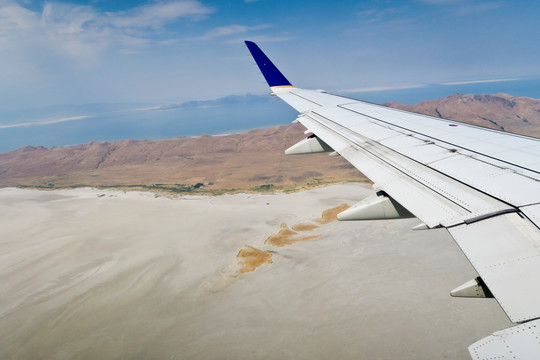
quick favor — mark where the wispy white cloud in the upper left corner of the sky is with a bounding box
[0,0,214,62]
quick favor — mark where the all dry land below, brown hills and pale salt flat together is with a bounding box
[0,95,540,360]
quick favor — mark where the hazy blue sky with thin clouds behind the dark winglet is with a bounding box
[0,0,540,113]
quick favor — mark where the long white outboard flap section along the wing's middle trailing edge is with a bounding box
[299,112,509,227]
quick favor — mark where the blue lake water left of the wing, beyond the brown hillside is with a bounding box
[0,97,296,152]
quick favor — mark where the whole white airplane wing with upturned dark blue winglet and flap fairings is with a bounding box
[246,41,540,360]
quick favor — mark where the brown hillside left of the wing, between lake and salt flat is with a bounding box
[0,125,363,192]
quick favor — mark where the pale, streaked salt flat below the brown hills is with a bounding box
[0,184,510,359]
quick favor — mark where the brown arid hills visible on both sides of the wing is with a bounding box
[0,94,540,194]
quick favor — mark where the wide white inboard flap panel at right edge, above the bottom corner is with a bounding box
[448,213,540,322]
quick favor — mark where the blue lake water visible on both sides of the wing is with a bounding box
[0,79,540,153]
